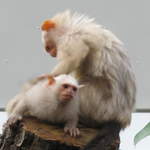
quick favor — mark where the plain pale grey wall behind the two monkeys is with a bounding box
[0,0,150,108]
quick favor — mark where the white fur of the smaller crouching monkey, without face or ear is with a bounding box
[6,75,79,127]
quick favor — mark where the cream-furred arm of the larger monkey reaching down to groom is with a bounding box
[51,39,89,76]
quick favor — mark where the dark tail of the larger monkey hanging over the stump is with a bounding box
[83,121,121,150]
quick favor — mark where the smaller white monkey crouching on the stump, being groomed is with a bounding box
[6,75,81,136]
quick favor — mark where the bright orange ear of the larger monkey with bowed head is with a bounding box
[41,20,56,31]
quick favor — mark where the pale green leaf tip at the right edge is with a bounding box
[134,122,150,145]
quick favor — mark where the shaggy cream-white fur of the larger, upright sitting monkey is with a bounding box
[42,11,136,128]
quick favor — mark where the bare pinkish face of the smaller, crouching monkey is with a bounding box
[59,84,77,102]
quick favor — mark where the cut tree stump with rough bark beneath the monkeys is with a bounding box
[0,117,119,150]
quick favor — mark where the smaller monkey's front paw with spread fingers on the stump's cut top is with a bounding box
[64,127,80,137]
